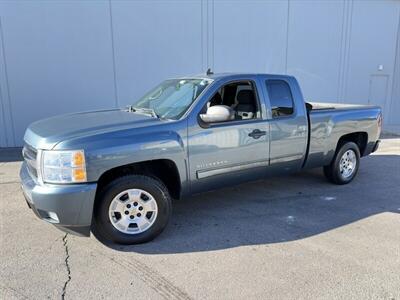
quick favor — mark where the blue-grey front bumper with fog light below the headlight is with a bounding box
[20,162,97,236]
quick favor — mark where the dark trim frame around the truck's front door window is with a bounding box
[197,79,263,129]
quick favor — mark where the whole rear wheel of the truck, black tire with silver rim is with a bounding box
[324,142,360,184]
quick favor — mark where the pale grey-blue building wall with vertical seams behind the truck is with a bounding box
[0,0,400,147]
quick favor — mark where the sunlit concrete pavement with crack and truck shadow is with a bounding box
[0,137,400,299]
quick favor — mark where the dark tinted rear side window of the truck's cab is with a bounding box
[266,80,293,118]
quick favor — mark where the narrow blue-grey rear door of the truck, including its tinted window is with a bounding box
[261,75,308,172]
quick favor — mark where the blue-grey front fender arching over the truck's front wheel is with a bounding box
[52,128,187,187]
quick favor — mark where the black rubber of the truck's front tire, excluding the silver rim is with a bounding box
[92,175,172,245]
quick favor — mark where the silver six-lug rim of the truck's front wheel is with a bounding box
[108,189,158,234]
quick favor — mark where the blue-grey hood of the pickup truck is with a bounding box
[24,109,161,149]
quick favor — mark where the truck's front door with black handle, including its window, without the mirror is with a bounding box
[188,79,269,193]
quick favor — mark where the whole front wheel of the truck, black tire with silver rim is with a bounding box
[92,175,172,245]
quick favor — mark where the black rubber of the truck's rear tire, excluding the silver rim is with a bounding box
[324,142,360,184]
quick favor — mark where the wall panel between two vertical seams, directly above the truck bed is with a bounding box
[287,1,348,102]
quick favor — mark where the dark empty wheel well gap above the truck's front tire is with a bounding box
[97,159,181,199]
